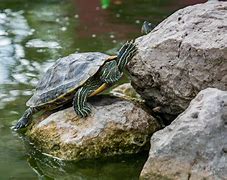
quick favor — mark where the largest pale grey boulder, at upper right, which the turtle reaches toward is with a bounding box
[128,1,227,120]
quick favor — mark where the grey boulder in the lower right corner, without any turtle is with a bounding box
[140,88,227,180]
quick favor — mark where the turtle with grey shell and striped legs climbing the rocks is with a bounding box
[13,40,137,130]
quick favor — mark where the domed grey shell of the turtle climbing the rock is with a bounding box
[26,52,109,107]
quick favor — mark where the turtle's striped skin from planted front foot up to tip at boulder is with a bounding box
[73,42,137,117]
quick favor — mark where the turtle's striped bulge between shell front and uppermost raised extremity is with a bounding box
[100,61,123,84]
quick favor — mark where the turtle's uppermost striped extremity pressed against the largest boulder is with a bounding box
[117,40,138,72]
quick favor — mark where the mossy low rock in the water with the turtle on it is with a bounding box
[26,96,160,160]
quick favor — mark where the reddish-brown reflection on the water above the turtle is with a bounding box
[75,0,140,43]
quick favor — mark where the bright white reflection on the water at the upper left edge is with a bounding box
[0,9,31,84]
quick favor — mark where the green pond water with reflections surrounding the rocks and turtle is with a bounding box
[0,0,206,180]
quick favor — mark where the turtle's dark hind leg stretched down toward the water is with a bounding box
[13,107,38,130]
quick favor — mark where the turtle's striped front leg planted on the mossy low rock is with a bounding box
[73,86,95,118]
